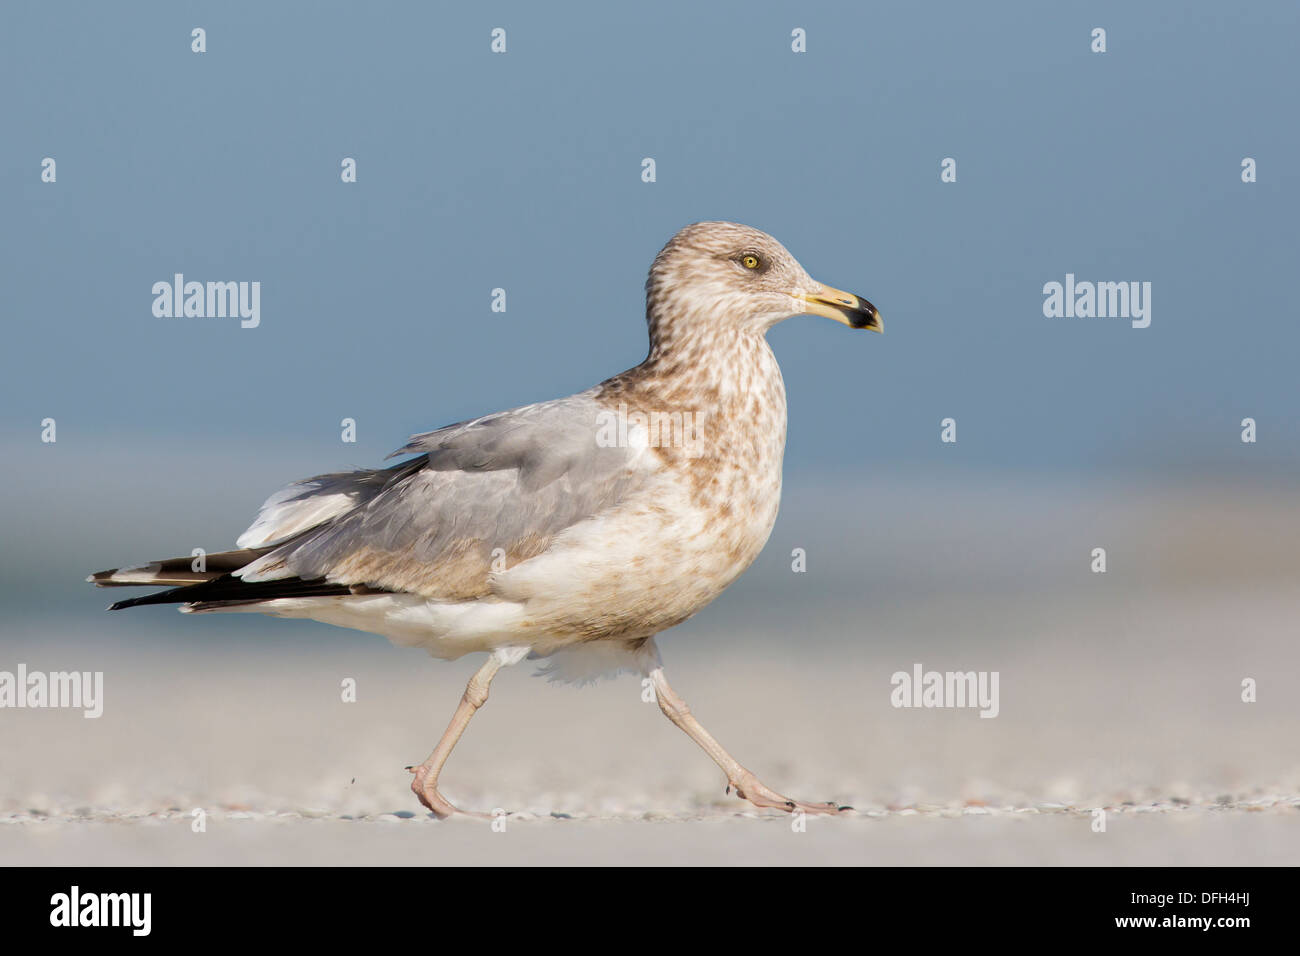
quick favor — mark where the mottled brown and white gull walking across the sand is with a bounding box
[87,222,883,818]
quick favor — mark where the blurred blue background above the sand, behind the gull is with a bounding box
[0,3,1300,613]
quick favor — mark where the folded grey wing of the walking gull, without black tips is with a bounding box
[239,393,647,600]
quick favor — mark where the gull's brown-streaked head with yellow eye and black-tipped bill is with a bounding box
[646,222,884,339]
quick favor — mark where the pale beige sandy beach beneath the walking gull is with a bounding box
[0,548,1300,865]
